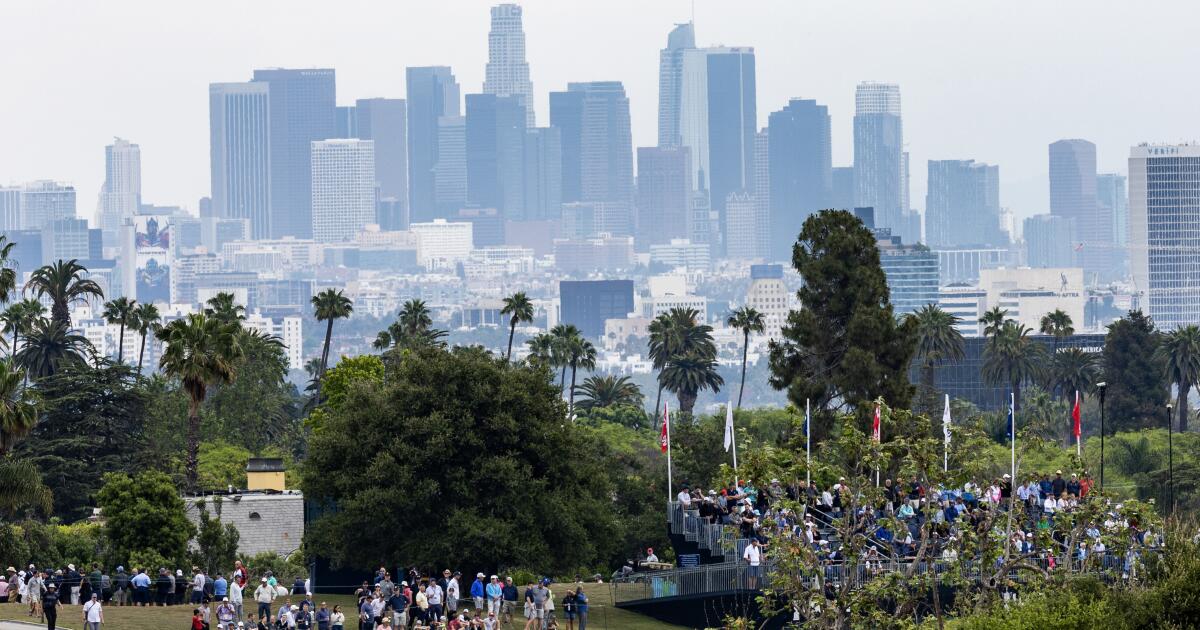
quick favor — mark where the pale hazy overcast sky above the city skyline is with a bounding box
[0,0,1200,228]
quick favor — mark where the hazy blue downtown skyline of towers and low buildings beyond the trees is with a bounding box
[9,5,1200,388]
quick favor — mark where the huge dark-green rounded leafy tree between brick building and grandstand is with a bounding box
[302,348,618,571]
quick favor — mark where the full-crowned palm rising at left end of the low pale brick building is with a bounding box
[155,313,242,492]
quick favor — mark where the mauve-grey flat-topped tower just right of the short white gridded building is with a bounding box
[354,98,408,224]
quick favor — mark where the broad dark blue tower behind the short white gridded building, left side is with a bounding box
[254,68,337,239]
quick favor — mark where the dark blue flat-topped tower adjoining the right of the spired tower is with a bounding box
[707,48,757,250]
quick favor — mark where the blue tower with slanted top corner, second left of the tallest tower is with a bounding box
[406,66,466,221]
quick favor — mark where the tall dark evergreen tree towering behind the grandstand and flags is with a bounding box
[770,210,916,431]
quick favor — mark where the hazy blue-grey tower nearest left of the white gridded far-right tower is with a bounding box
[1050,139,1117,281]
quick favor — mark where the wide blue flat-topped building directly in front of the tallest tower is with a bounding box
[467,94,527,218]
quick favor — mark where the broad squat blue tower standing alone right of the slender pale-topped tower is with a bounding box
[925,160,1008,247]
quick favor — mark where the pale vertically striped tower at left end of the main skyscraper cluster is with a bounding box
[209,83,271,239]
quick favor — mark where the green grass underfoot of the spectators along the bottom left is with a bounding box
[0,584,680,630]
